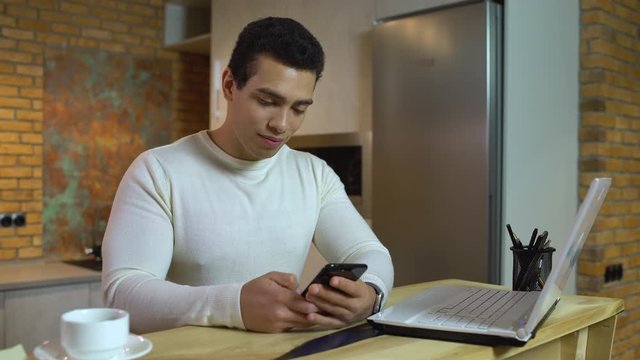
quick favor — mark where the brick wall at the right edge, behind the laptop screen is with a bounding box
[578,0,640,359]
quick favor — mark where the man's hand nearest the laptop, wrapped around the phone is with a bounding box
[306,276,376,328]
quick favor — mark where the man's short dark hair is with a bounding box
[229,17,324,88]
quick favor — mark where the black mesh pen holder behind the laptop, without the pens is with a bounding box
[510,246,556,291]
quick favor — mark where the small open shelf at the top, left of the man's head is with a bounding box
[164,0,211,54]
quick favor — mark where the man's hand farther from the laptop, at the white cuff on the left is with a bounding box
[240,271,318,333]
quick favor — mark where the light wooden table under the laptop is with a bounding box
[144,280,623,360]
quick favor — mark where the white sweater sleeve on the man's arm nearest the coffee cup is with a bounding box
[102,155,243,333]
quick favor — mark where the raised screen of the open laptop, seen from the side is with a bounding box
[525,178,611,332]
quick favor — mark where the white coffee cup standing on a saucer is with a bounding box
[60,308,129,360]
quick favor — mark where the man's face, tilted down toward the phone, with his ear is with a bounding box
[219,56,316,160]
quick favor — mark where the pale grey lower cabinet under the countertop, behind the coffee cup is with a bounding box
[0,281,102,353]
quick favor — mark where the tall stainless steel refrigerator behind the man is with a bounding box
[371,1,502,285]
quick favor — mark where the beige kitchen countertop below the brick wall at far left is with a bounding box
[0,259,100,291]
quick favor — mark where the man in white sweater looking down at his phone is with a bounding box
[102,18,393,333]
